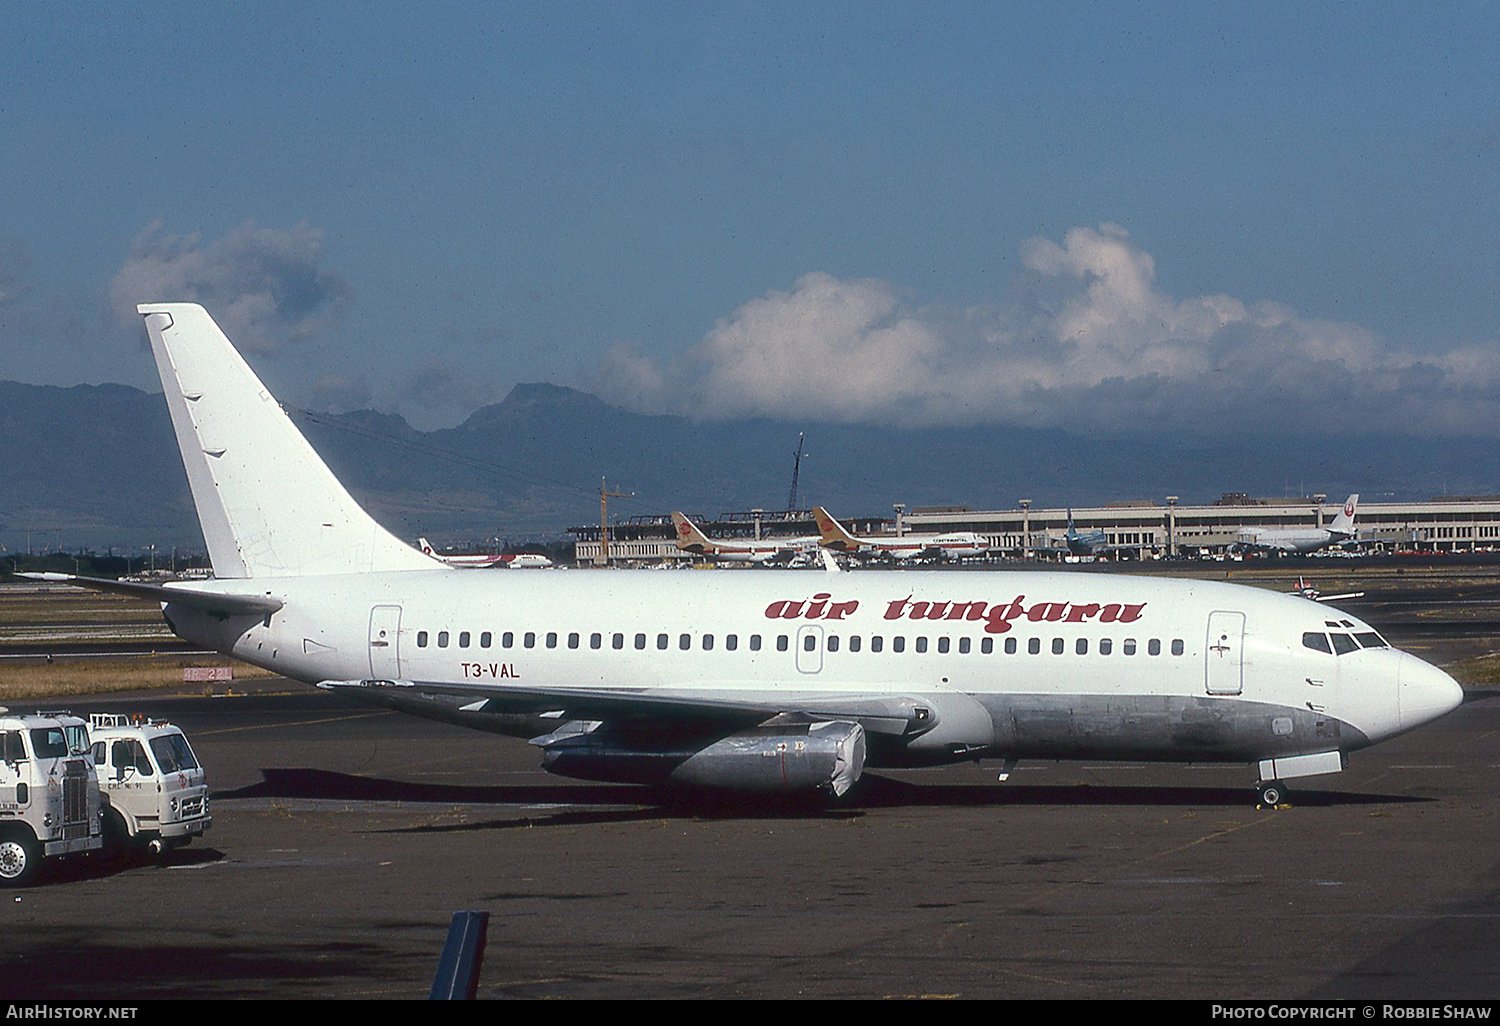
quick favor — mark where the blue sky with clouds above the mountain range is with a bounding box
[0,2,1500,434]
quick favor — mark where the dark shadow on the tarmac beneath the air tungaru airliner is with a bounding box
[213,768,1433,831]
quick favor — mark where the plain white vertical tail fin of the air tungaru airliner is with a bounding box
[137,303,444,578]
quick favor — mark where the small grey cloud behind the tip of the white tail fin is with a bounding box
[108,221,350,353]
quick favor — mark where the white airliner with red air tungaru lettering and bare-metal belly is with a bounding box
[23,303,1463,804]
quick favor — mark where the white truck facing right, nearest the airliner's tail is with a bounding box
[90,713,213,854]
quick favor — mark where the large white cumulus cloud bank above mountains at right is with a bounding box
[597,225,1500,434]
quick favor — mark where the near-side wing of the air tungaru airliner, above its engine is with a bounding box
[318,680,936,737]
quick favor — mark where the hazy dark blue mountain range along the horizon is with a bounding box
[0,381,1500,552]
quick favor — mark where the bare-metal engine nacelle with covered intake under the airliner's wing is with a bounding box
[533,720,864,797]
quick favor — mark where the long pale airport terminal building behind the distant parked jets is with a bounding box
[569,494,1500,563]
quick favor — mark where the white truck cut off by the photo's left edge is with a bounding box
[0,708,104,887]
